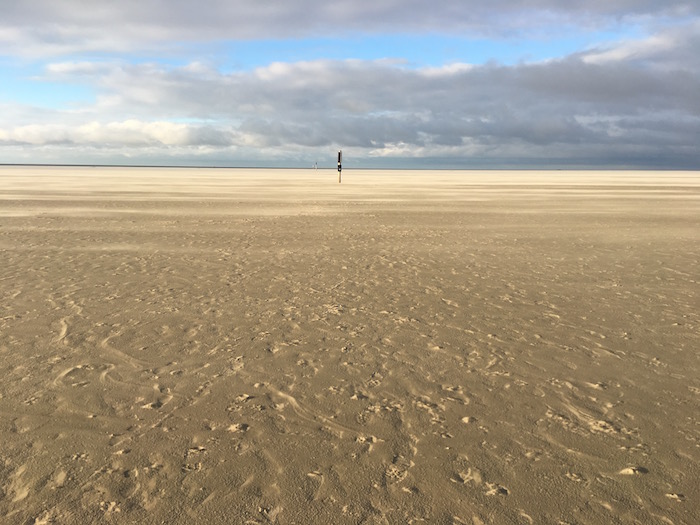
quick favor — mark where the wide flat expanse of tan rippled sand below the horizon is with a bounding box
[0,168,700,525]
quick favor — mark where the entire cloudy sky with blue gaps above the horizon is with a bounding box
[0,0,700,169]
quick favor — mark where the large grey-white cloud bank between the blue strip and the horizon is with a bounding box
[0,23,700,168]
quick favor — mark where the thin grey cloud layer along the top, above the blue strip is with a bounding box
[0,0,700,56]
